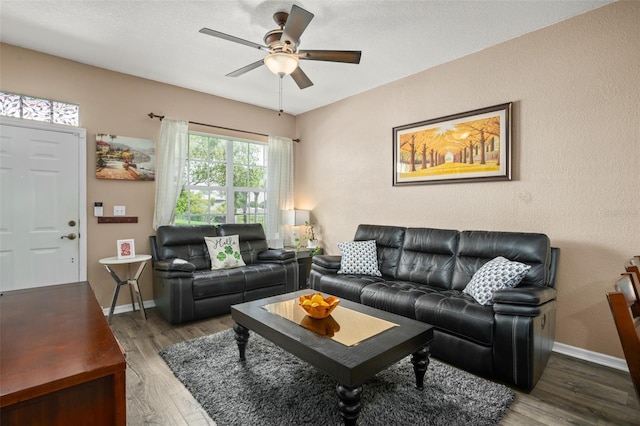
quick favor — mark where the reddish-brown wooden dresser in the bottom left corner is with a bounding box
[0,282,126,426]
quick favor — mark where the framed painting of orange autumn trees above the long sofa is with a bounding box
[393,103,512,186]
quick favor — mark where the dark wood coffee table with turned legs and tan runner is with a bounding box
[231,289,433,425]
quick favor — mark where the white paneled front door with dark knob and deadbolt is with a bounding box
[0,119,87,291]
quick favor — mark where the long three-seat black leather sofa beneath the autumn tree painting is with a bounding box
[310,225,559,390]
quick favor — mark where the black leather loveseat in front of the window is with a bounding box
[149,224,298,324]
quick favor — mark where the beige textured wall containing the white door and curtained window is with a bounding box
[0,44,295,307]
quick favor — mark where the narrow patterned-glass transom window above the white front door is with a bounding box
[0,92,80,126]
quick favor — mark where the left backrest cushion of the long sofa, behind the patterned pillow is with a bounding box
[353,225,405,278]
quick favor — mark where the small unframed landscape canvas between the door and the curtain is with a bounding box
[96,133,156,181]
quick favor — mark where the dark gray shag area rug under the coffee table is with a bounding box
[160,330,515,426]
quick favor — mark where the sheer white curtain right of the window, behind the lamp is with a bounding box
[265,136,293,243]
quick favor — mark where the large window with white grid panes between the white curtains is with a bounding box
[175,133,267,225]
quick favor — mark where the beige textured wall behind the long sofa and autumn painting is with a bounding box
[296,1,640,357]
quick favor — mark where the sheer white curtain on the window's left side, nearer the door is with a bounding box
[153,117,189,230]
